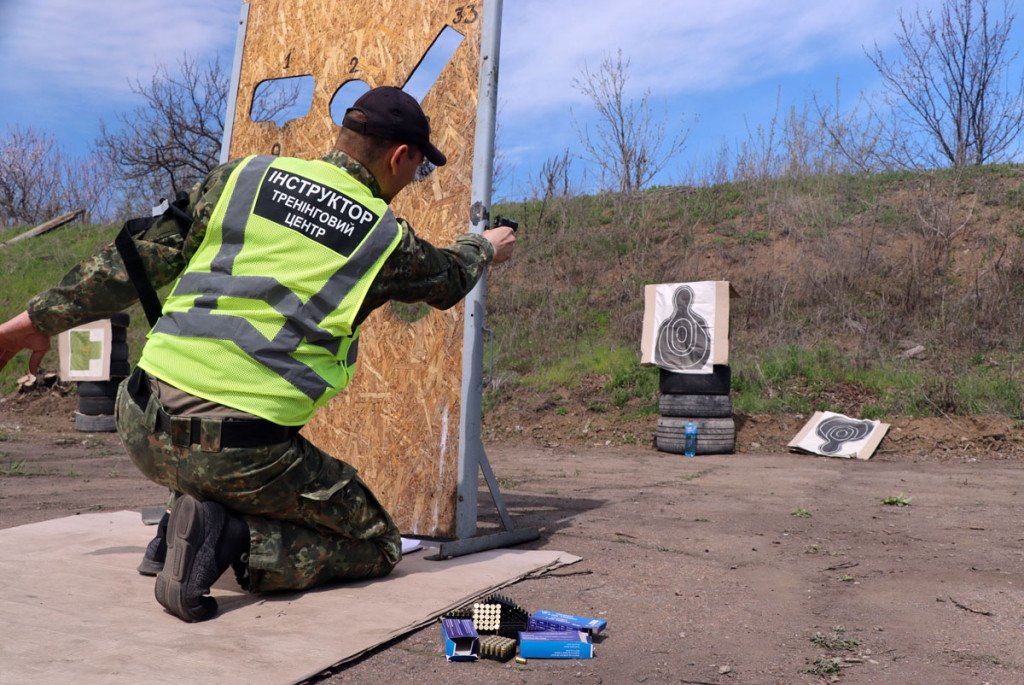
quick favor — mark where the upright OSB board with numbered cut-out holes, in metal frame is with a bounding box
[230,0,483,537]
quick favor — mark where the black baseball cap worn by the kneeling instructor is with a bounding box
[341,86,447,167]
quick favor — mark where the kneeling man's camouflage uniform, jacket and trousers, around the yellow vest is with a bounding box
[28,151,494,592]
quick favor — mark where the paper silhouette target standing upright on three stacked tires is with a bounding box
[640,281,732,374]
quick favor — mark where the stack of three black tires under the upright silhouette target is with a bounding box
[654,365,736,455]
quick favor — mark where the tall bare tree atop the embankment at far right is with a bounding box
[868,0,1024,168]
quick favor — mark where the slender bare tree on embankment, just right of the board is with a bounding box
[572,50,688,192]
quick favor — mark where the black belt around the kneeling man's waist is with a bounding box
[127,368,301,452]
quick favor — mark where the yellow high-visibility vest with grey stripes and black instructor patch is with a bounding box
[139,156,401,426]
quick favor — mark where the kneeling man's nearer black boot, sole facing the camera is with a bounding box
[155,495,249,622]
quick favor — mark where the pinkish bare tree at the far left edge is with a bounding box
[0,127,110,226]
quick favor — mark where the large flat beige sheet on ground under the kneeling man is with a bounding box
[0,511,580,685]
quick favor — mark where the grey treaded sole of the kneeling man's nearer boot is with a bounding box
[154,495,217,623]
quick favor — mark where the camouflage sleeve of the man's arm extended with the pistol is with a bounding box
[355,219,495,325]
